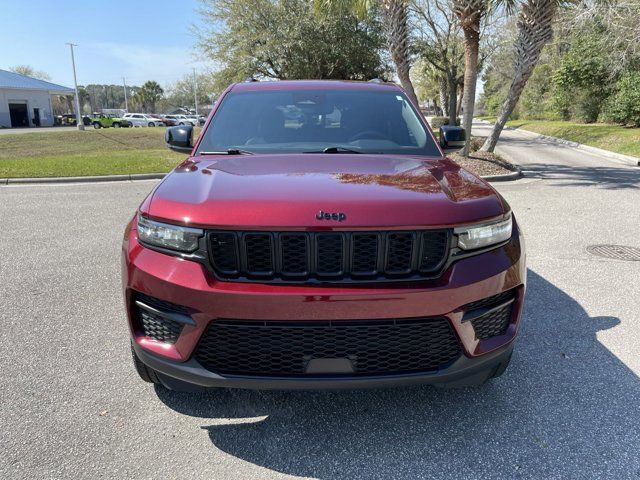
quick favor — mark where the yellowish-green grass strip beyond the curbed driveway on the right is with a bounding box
[480,117,640,157]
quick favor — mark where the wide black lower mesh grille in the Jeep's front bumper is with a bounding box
[195,318,461,376]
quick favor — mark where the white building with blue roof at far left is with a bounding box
[0,70,74,128]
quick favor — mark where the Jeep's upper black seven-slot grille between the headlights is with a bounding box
[207,230,451,282]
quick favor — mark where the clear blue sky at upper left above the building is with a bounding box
[0,0,207,87]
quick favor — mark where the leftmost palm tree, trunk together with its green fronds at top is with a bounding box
[315,0,418,105]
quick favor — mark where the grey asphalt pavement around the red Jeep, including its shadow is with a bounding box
[0,126,640,479]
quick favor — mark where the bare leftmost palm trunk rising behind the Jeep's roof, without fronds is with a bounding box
[381,0,418,106]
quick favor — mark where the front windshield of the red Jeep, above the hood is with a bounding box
[196,90,440,156]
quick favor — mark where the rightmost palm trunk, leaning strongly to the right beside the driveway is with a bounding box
[480,0,558,152]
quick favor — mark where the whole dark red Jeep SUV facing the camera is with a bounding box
[122,81,526,390]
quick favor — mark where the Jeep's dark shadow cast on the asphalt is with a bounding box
[157,271,640,479]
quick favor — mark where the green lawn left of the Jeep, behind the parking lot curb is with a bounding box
[0,127,186,178]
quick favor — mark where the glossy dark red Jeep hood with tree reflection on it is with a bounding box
[141,154,504,229]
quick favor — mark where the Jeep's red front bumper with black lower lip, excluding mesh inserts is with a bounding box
[122,219,526,389]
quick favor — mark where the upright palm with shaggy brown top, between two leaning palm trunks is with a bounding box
[453,0,489,157]
